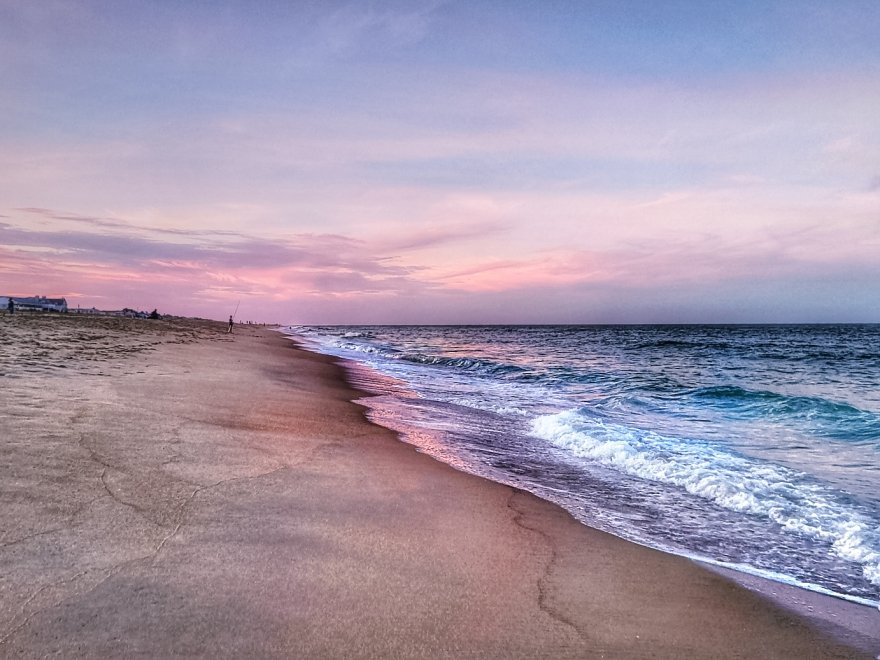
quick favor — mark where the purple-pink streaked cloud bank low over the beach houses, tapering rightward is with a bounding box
[0,209,426,314]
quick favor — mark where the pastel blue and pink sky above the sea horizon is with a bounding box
[0,0,880,324]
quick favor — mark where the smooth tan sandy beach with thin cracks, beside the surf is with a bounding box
[0,314,880,658]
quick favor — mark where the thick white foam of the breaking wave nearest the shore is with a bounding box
[531,410,880,586]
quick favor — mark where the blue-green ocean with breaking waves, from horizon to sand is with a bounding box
[287,325,880,607]
